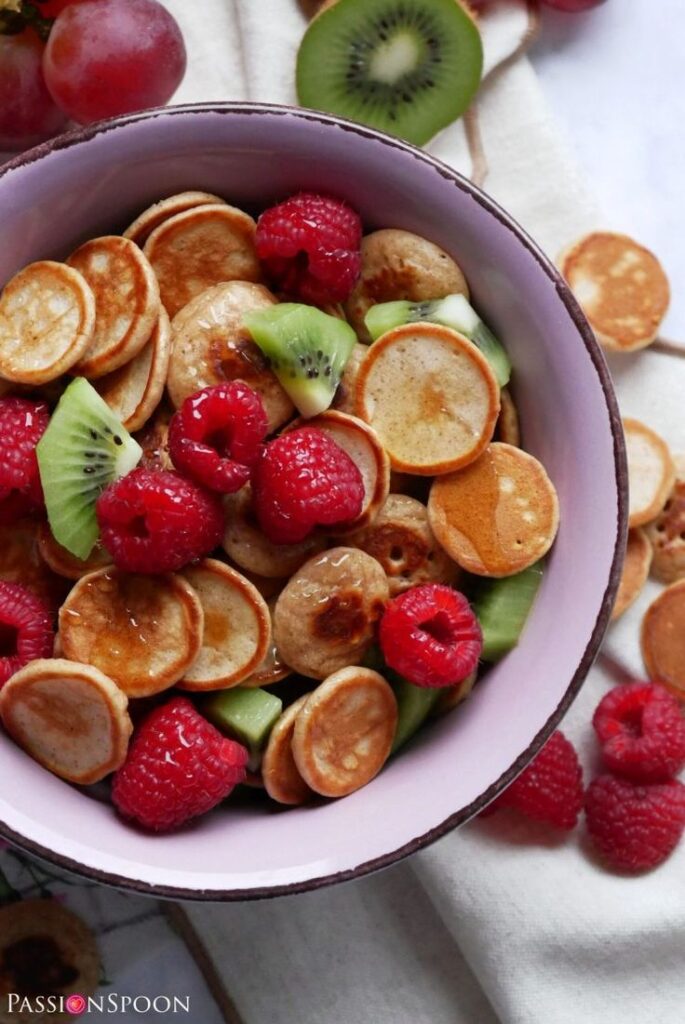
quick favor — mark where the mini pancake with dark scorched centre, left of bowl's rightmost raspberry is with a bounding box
[273,548,389,679]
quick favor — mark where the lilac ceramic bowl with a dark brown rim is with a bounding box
[0,103,627,900]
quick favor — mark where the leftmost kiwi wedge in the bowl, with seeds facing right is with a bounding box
[36,377,142,560]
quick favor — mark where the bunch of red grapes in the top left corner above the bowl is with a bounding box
[0,0,186,151]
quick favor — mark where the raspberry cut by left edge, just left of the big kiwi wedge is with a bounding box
[0,398,50,524]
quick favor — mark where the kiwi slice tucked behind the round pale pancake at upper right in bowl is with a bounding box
[365,295,511,387]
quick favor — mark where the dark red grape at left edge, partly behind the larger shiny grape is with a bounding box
[0,29,67,150]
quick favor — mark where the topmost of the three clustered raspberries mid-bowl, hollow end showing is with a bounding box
[169,381,268,495]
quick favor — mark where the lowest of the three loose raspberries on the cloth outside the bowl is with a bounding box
[585,775,685,871]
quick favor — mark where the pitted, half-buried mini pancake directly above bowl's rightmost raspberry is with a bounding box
[347,495,460,597]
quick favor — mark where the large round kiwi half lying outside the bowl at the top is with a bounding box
[297,0,483,145]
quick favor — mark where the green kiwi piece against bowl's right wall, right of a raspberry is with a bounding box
[473,561,544,662]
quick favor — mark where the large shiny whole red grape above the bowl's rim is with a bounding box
[43,0,185,124]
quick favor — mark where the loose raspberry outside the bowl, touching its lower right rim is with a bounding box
[487,729,583,830]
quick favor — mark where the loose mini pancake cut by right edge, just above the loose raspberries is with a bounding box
[641,580,685,700]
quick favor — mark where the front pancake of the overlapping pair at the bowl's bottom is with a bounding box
[293,666,397,797]
